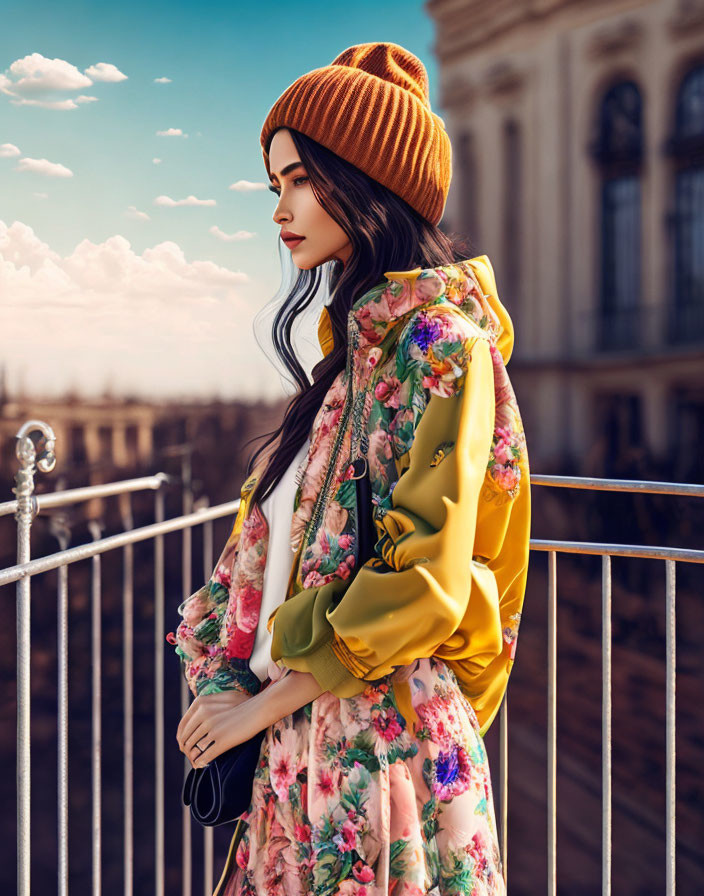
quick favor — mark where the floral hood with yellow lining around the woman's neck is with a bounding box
[318,255,514,364]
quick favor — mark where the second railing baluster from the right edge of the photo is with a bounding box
[601,554,611,896]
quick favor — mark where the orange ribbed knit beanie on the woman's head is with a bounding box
[261,43,452,224]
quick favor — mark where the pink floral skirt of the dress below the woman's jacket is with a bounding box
[216,657,506,896]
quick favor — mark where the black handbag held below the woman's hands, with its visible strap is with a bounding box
[182,459,377,827]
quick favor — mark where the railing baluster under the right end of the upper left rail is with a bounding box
[154,488,165,896]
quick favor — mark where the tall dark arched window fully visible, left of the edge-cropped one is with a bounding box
[592,81,643,349]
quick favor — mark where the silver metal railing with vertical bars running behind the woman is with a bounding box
[0,420,704,896]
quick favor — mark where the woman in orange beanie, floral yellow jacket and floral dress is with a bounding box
[171,43,530,896]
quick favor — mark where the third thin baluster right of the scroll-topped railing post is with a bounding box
[122,495,134,896]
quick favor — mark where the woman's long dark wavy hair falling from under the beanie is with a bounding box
[247,128,474,504]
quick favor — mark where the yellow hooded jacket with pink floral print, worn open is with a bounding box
[167,255,530,735]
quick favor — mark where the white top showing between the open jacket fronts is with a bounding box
[249,439,310,681]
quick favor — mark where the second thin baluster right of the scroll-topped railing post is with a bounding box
[88,520,103,896]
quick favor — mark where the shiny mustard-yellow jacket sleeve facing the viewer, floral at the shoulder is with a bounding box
[269,311,502,697]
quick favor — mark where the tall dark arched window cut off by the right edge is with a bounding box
[667,64,704,342]
